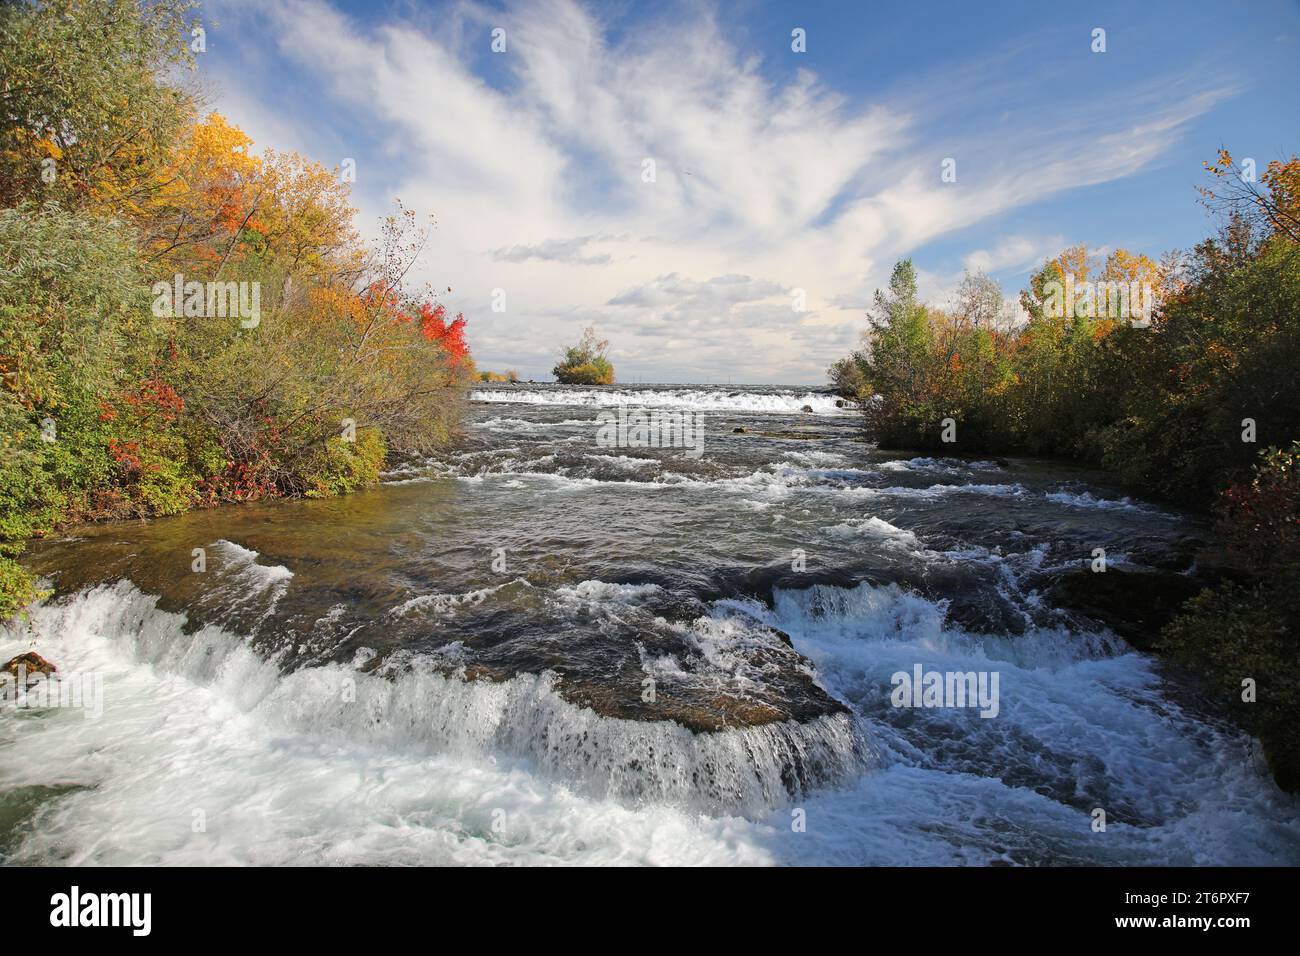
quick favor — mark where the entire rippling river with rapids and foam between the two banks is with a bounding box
[0,385,1300,865]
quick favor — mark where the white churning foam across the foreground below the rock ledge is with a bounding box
[0,580,1300,865]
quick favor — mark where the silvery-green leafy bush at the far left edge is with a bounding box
[0,204,155,613]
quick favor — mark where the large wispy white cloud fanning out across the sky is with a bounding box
[208,0,1227,382]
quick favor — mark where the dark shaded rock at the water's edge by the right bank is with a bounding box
[1048,567,1204,650]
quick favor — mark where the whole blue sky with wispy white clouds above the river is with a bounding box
[198,0,1300,385]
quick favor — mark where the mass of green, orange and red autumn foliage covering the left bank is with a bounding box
[0,7,475,617]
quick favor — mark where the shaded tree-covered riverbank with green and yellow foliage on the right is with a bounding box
[831,180,1300,791]
